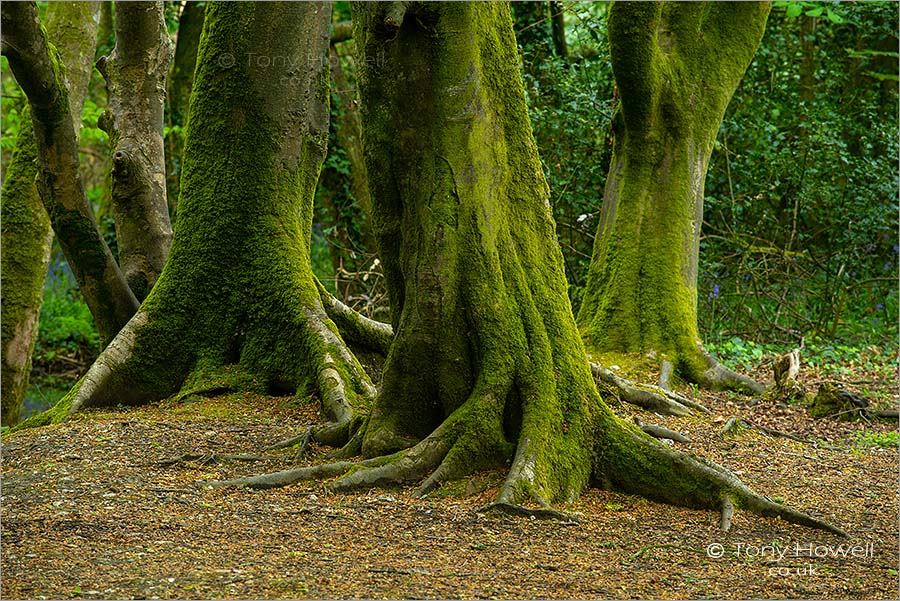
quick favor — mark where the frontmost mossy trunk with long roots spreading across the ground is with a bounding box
[211,2,837,531]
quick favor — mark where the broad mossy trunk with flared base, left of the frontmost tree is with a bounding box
[18,2,374,437]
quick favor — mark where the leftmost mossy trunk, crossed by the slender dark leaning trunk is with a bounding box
[0,2,100,425]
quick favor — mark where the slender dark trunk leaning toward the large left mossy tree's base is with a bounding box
[2,2,138,344]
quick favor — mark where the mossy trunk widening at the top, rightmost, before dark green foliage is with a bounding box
[578,2,769,391]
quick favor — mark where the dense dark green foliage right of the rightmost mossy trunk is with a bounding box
[699,2,898,346]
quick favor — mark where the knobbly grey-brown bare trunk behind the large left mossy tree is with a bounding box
[97,1,172,300]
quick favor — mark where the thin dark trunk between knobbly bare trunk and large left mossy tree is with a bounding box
[166,0,206,218]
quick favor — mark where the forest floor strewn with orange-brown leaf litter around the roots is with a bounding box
[0,358,898,599]
